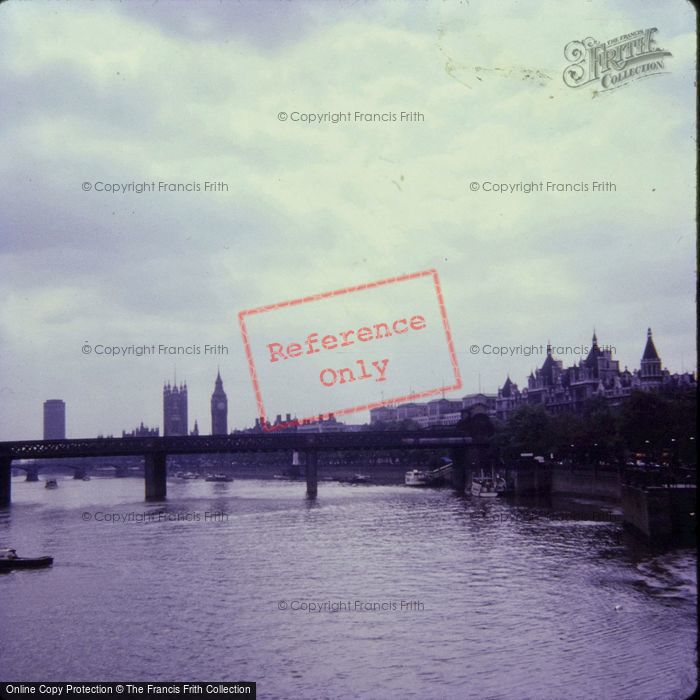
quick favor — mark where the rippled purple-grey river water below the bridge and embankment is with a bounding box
[0,478,697,700]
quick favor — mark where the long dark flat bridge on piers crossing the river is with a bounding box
[0,429,487,507]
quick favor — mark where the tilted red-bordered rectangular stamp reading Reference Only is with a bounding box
[238,270,462,429]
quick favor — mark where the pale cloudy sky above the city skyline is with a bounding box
[0,0,695,440]
